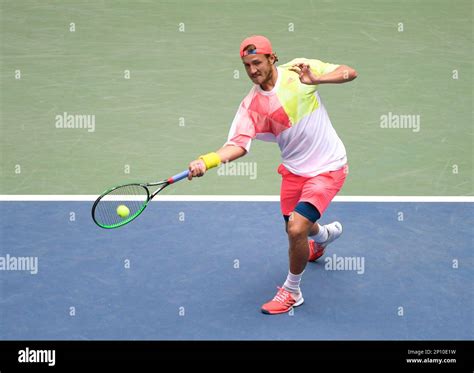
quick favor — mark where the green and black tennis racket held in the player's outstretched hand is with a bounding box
[92,170,189,229]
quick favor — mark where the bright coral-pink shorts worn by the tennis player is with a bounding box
[278,164,348,216]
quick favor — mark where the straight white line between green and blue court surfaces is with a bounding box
[0,194,474,203]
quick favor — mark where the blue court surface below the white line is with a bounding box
[0,201,474,340]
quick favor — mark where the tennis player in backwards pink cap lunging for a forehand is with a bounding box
[189,36,357,314]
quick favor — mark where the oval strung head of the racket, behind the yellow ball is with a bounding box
[94,184,148,228]
